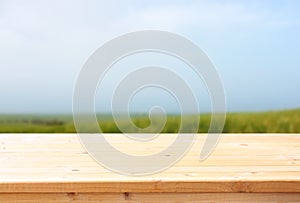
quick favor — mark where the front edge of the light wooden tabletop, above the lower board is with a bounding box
[0,180,300,193]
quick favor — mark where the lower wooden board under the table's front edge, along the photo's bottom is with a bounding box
[0,193,300,203]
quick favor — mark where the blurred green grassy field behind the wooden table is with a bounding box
[0,109,300,133]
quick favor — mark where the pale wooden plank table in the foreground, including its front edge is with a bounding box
[0,134,300,203]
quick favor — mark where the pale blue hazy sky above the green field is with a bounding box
[0,0,300,113]
